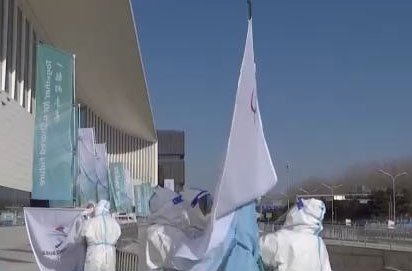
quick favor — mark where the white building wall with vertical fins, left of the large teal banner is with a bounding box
[0,0,37,192]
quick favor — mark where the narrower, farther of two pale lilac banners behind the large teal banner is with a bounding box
[95,143,110,201]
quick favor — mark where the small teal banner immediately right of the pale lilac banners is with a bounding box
[109,163,129,213]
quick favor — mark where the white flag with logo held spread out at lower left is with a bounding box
[24,208,86,271]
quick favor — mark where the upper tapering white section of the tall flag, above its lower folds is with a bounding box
[215,20,277,218]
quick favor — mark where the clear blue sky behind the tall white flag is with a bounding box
[133,0,412,194]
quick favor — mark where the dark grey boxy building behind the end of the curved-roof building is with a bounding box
[157,130,185,192]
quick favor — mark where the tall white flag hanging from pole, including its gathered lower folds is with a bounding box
[171,20,277,271]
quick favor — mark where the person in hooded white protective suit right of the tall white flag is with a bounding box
[260,199,331,271]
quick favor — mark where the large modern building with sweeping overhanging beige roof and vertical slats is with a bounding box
[0,0,158,210]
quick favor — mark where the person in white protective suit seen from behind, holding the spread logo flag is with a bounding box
[82,200,121,271]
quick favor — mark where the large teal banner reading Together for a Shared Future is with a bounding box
[32,44,75,200]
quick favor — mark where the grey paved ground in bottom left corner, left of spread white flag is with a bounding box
[0,227,39,271]
